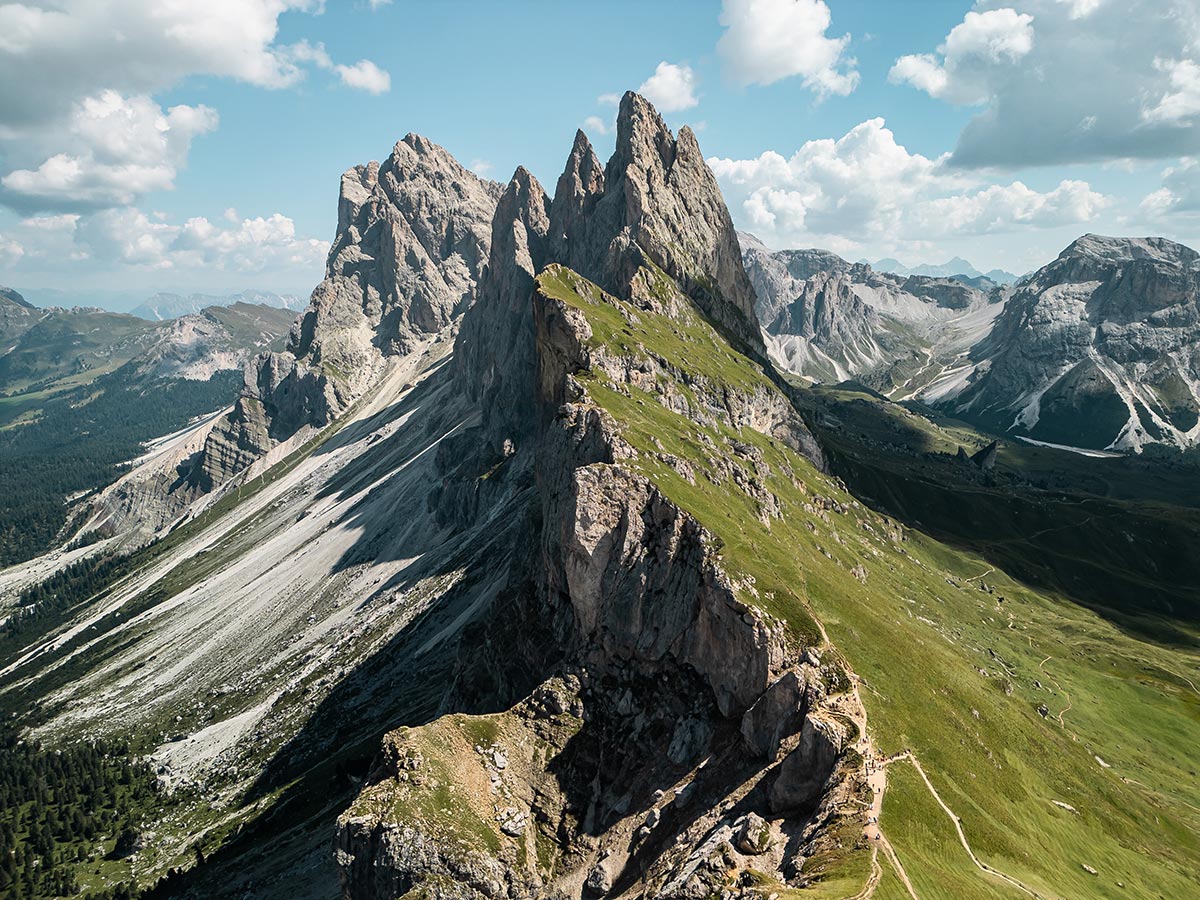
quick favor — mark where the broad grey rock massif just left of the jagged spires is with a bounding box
[181,134,500,491]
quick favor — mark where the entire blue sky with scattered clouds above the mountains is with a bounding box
[0,0,1200,307]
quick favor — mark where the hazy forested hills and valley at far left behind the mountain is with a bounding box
[0,288,295,566]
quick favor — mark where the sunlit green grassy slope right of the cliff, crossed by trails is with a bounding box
[540,272,1200,898]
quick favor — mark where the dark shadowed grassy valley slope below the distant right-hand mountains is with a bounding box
[797,386,1200,646]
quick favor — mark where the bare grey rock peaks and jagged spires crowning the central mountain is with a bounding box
[96,92,777,547]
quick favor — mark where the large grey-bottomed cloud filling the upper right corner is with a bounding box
[890,0,1200,168]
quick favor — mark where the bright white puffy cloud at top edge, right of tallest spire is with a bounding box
[716,0,859,96]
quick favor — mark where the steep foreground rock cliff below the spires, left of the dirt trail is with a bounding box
[337,266,856,899]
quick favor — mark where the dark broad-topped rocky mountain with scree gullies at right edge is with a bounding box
[946,235,1200,450]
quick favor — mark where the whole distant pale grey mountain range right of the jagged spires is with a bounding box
[742,234,1200,451]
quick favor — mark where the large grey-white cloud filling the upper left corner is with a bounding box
[0,0,390,210]
